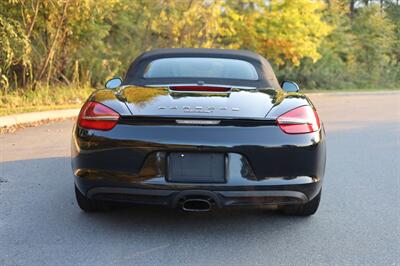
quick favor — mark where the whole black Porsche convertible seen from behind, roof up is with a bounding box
[71,49,326,215]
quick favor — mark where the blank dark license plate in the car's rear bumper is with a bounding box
[167,152,225,183]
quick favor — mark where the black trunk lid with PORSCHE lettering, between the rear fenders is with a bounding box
[118,86,281,119]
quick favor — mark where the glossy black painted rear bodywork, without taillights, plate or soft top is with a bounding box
[71,86,326,209]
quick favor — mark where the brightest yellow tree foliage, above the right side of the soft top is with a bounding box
[230,0,332,65]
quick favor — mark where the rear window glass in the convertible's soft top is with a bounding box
[143,57,258,80]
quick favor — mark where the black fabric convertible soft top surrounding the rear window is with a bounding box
[123,48,280,89]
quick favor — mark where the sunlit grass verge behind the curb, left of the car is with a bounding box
[0,86,94,116]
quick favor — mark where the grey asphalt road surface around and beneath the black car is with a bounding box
[0,93,400,265]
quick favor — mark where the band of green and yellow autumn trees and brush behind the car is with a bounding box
[0,0,400,93]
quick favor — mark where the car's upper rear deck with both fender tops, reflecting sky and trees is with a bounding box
[89,85,312,120]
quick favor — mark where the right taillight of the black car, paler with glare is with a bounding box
[277,106,321,134]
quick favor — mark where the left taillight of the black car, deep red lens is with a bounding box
[78,102,120,130]
